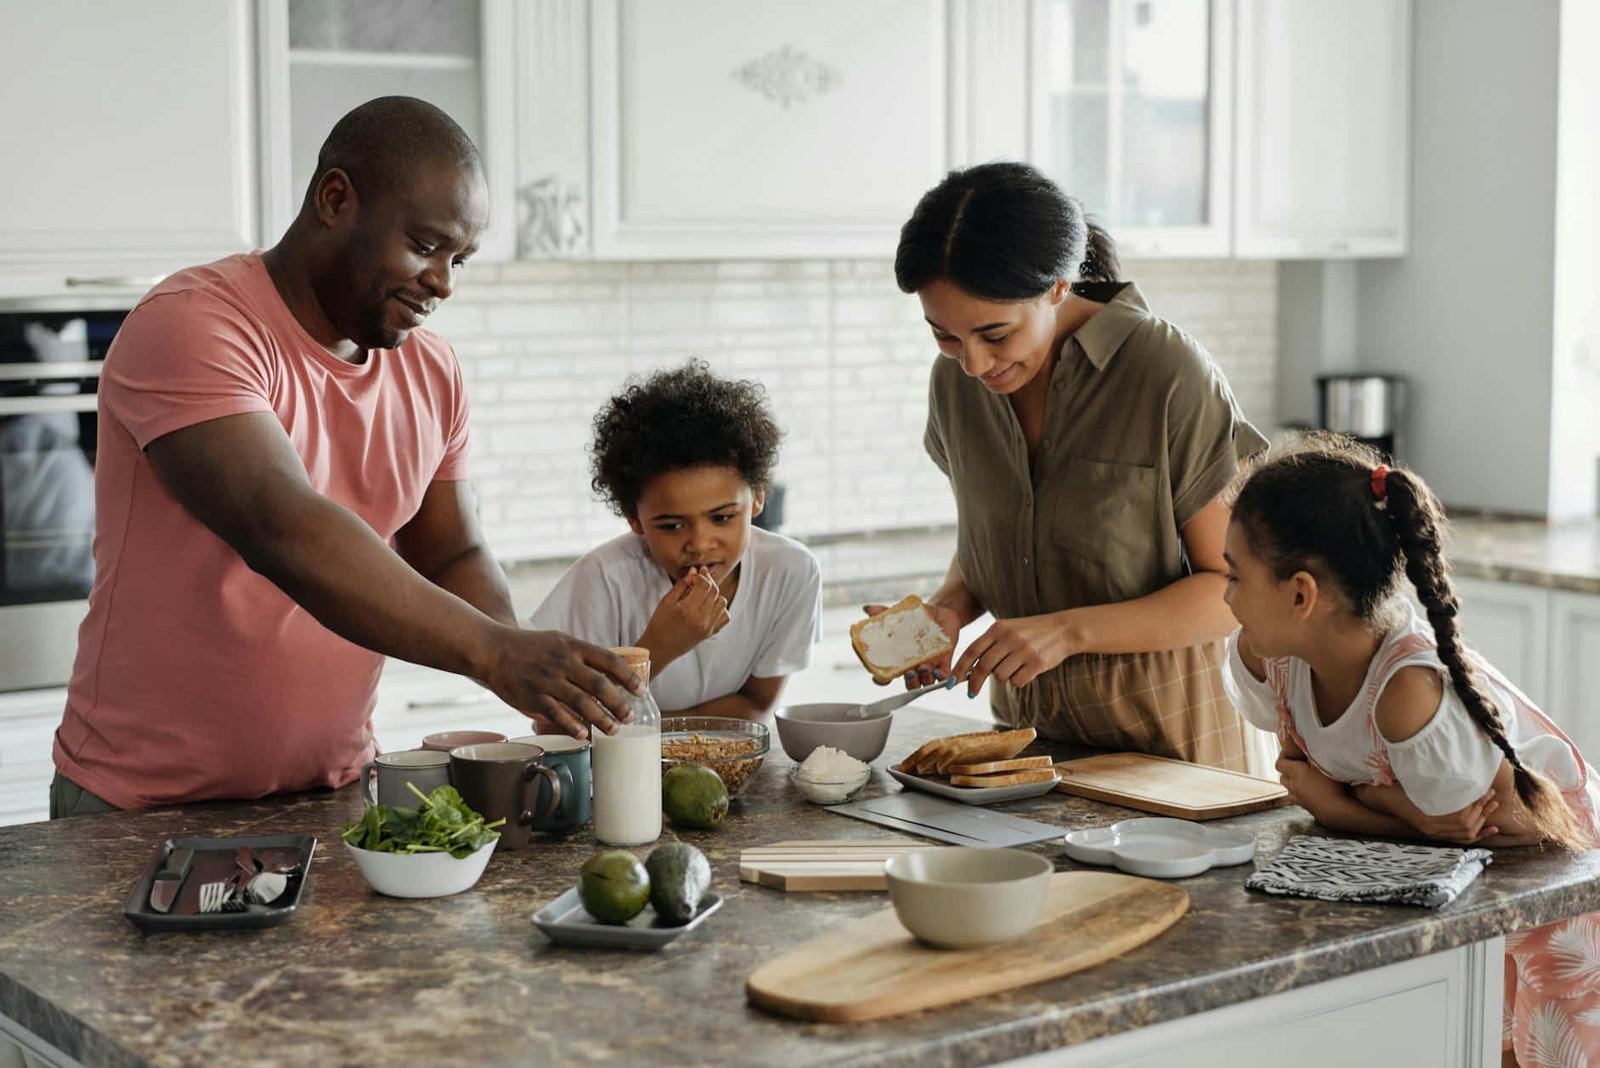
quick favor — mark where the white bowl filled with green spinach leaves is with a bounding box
[341,787,502,897]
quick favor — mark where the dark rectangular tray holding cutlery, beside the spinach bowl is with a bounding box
[122,835,317,934]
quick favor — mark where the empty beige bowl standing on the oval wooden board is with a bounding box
[883,846,1054,950]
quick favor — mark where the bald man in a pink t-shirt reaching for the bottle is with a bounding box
[50,98,638,817]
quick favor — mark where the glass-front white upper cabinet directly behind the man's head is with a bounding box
[259,0,517,262]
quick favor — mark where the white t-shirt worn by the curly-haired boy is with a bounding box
[530,528,822,711]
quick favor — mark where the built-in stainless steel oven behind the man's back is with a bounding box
[0,312,126,691]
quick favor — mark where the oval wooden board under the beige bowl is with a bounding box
[744,871,1189,1023]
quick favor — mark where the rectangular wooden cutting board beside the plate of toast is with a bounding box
[1056,753,1288,820]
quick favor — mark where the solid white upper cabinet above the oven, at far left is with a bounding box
[0,0,256,301]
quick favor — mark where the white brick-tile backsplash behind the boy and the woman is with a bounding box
[430,261,1277,559]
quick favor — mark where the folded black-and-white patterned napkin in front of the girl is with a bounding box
[1245,835,1493,908]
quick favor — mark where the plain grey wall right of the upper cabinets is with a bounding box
[1357,0,1555,513]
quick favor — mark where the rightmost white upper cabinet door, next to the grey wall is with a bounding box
[1234,0,1411,259]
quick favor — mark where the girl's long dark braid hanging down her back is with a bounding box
[1386,468,1589,852]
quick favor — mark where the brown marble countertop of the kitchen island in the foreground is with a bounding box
[0,711,1600,1068]
